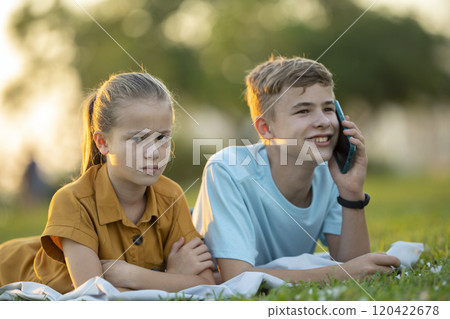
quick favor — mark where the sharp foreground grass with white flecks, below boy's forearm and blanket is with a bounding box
[230,248,450,301]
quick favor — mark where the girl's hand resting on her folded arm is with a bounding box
[166,237,214,275]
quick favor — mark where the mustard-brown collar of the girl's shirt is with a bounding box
[95,165,159,227]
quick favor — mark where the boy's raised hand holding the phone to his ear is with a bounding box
[328,116,368,201]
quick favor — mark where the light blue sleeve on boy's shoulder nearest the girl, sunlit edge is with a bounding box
[193,163,257,266]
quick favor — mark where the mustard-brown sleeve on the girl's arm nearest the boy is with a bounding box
[164,195,201,261]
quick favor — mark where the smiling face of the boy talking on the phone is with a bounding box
[268,84,339,164]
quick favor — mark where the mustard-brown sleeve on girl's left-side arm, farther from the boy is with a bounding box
[41,188,98,263]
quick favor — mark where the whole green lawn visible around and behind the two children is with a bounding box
[0,173,450,300]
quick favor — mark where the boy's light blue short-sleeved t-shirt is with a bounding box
[192,144,342,266]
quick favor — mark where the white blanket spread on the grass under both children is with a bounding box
[0,242,423,301]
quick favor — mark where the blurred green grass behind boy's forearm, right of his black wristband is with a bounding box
[365,175,450,251]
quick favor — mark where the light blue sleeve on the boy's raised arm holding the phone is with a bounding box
[320,183,342,246]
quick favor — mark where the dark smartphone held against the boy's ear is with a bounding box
[333,100,356,174]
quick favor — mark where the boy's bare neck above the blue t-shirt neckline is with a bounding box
[266,145,316,208]
